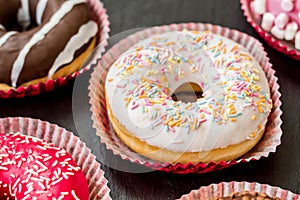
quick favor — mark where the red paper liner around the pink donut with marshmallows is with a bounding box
[241,0,300,60]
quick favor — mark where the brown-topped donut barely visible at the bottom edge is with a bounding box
[217,191,280,200]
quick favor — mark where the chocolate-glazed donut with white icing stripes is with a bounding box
[0,0,98,90]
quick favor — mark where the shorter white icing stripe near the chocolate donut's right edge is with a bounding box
[48,21,98,79]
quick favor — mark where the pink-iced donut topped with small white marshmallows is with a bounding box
[250,0,300,50]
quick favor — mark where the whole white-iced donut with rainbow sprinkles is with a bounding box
[105,31,272,163]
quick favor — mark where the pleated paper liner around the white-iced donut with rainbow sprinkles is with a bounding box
[89,23,282,174]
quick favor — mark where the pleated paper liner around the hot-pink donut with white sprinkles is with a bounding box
[0,117,111,200]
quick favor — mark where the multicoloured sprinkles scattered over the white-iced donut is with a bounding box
[108,31,272,133]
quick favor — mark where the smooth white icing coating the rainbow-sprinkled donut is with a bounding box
[105,32,270,152]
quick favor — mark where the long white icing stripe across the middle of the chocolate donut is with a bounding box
[11,0,85,87]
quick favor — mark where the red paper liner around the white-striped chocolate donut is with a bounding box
[0,0,110,98]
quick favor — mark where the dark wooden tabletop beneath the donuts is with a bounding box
[0,0,300,200]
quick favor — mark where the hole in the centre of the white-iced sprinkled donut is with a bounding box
[171,82,203,103]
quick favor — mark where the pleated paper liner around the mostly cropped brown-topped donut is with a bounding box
[180,181,300,200]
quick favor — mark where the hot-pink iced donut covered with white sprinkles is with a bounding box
[0,133,89,200]
